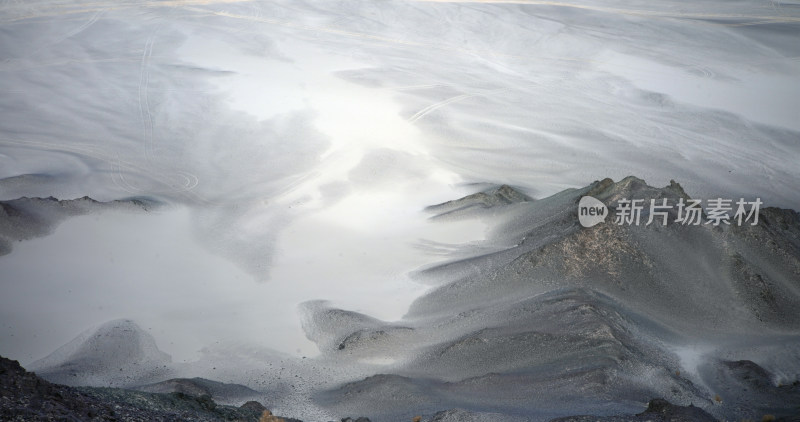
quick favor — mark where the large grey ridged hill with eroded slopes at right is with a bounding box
[316,177,800,420]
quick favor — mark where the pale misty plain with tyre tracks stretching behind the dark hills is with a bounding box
[0,0,800,412]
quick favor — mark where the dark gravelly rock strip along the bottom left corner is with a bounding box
[0,357,300,422]
